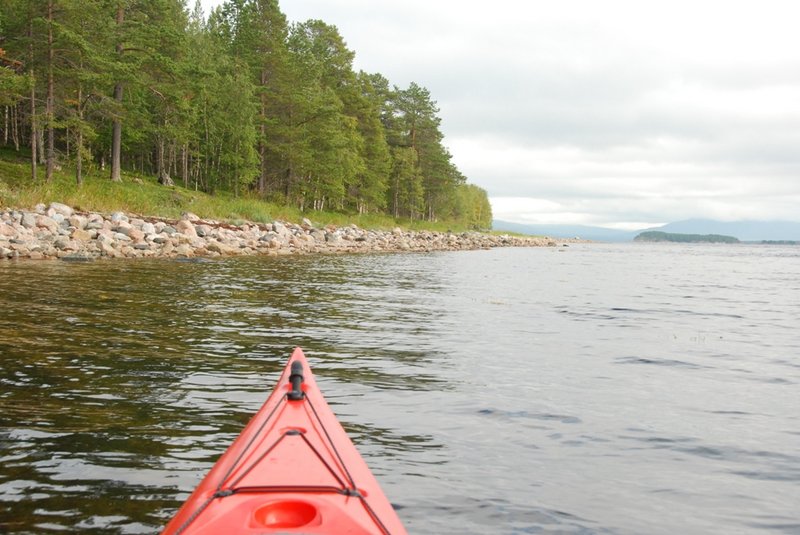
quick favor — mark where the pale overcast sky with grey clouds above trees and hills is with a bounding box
[203,0,800,229]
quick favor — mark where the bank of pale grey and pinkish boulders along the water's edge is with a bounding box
[0,203,560,261]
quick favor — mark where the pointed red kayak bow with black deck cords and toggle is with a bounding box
[162,347,406,535]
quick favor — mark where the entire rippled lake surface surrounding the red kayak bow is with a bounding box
[0,244,800,534]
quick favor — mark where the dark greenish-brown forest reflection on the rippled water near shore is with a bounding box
[0,257,445,533]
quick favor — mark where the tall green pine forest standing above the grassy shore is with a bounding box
[0,0,492,228]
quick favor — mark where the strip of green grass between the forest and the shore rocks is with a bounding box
[0,147,488,232]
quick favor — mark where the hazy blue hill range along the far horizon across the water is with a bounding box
[493,219,800,242]
